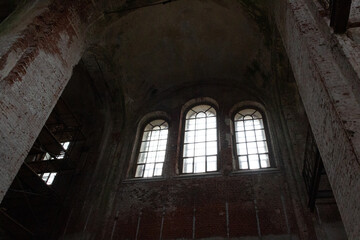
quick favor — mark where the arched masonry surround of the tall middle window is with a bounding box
[176,97,221,176]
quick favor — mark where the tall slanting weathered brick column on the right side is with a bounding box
[274,0,360,239]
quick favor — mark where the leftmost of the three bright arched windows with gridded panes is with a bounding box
[135,120,169,178]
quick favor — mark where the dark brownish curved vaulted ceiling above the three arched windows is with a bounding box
[83,0,271,112]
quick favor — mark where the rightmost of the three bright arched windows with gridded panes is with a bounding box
[234,109,270,169]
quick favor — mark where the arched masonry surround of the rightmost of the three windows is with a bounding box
[229,101,278,172]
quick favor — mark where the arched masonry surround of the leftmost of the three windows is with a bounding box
[126,111,171,180]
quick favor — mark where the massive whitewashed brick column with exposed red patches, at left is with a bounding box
[0,0,94,201]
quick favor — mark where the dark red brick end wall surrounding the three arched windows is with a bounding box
[95,76,316,239]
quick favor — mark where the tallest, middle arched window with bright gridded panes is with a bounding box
[182,105,218,173]
